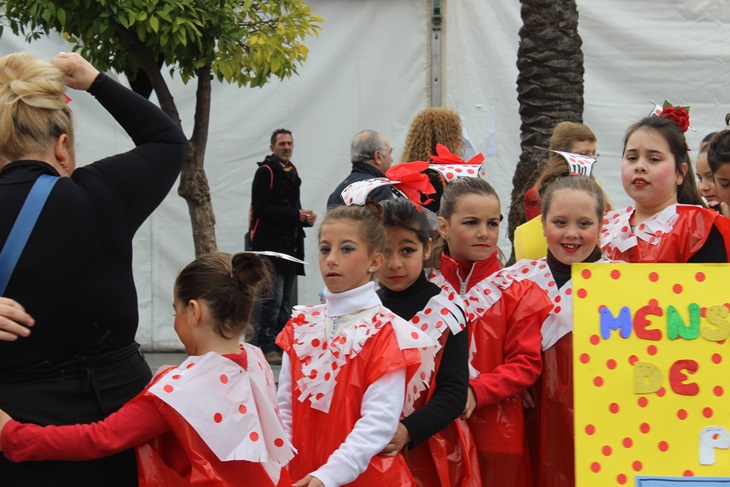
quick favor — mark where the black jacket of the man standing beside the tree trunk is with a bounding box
[249,154,304,276]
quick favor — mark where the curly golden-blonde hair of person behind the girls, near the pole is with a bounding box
[401,107,463,162]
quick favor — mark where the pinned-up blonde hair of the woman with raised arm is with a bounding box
[0,52,73,165]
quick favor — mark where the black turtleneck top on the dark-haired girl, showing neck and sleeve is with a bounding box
[378,274,469,448]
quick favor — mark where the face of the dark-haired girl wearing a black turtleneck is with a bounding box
[377,227,431,291]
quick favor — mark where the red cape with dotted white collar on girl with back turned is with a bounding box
[144,345,295,487]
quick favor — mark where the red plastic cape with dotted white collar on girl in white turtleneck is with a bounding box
[277,304,436,485]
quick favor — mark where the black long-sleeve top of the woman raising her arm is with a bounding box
[0,74,187,373]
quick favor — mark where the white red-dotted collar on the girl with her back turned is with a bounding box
[149,344,296,468]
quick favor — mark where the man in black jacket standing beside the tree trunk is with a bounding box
[249,129,317,364]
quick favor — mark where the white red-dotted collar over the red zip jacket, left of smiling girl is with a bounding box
[430,269,515,379]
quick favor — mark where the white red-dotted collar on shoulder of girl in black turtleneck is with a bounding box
[403,289,466,416]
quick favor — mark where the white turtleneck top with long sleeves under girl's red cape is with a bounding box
[277,282,406,487]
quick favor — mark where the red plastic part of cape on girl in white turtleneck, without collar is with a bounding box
[276,306,426,487]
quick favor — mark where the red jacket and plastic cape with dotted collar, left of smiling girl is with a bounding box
[431,254,552,485]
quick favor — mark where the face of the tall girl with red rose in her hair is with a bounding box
[621,127,687,213]
